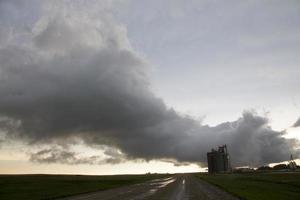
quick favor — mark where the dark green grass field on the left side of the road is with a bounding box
[0,174,170,200]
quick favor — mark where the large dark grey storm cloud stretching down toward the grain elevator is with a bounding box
[0,1,298,165]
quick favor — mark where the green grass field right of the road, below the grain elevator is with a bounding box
[198,172,300,200]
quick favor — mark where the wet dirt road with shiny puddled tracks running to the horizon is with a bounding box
[57,174,238,200]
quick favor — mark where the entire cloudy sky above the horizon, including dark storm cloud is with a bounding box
[0,0,300,174]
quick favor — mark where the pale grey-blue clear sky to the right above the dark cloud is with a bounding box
[116,0,300,129]
